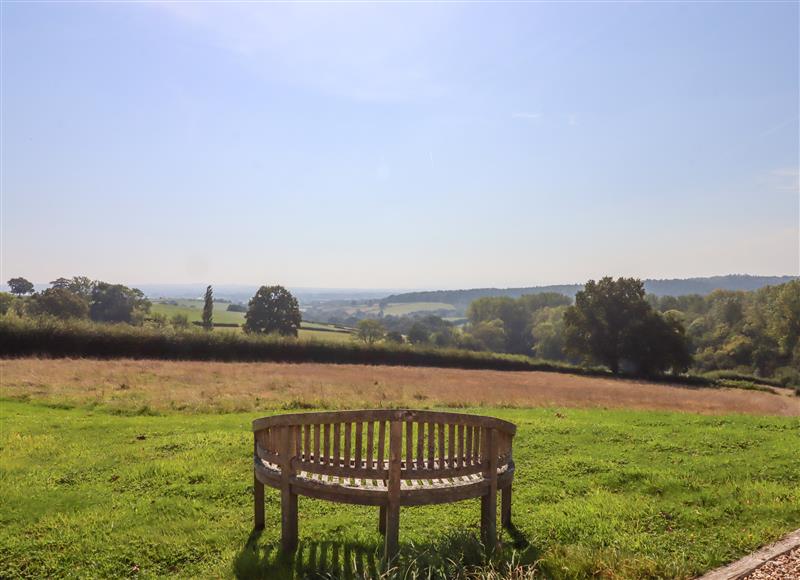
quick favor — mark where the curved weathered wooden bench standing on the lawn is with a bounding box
[253,409,516,560]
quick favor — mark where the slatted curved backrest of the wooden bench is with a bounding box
[253,410,516,480]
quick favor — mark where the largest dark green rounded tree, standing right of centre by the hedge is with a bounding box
[564,277,689,373]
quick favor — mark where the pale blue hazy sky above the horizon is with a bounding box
[2,2,800,288]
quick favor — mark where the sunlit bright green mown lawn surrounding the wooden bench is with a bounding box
[0,400,800,578]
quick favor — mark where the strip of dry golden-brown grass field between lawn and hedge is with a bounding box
[0,358,800,416]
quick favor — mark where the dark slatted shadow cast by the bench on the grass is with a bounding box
[233,528,539,580]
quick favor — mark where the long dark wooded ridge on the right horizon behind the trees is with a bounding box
[382,274,798,307]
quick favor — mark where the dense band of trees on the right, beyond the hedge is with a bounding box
[357,277,800,384]
